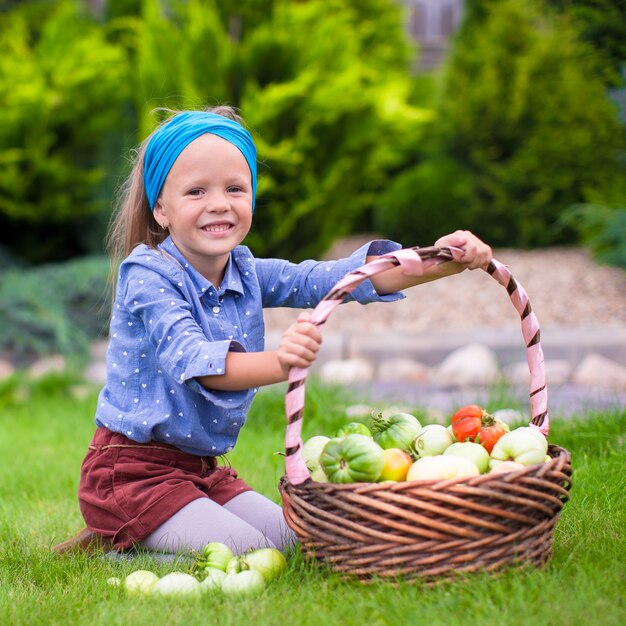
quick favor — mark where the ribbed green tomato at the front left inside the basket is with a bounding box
[320,434,385,483]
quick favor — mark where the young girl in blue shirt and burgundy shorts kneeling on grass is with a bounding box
[57,107,491,553]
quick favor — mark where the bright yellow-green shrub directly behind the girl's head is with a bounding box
[129,0,424,259]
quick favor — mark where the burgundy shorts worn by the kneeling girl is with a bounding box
[78,428,251,550]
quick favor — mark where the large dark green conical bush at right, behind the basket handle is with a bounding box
[377,0,626,247]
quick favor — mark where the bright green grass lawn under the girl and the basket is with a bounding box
[0,378,626,626]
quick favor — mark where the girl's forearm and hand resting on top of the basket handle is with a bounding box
[367,230,492,295]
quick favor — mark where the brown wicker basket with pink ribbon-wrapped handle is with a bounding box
[280,247,572,584]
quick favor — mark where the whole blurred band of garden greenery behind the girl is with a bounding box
[0,0,626,364]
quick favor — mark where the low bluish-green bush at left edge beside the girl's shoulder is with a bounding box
[0,257,110,362]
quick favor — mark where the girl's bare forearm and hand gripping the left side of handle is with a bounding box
[197,313,322,391]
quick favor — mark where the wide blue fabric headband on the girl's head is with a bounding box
[143,111,256,211]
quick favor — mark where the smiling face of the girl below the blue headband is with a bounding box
[154,134,252,287]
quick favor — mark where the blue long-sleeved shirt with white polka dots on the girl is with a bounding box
[95,238,403,456]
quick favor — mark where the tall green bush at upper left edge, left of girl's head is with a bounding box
[0,0,129,262]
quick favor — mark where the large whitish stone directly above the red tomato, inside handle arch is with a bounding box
[435,343,499,385]
